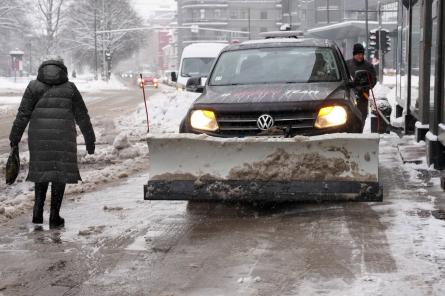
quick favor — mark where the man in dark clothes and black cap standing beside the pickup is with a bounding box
[347,43,377,130]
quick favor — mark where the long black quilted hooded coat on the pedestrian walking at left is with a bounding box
[9,61,96,183]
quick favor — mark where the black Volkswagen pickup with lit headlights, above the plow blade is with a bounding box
[180,32,363,137]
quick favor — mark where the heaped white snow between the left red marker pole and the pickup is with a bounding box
[148,90,200,133]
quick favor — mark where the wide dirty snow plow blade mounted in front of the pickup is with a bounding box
[144,134,382,202]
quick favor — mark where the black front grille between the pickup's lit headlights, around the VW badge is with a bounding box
[216,111,317,136]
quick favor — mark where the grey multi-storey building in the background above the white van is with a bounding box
[177,0,283,53]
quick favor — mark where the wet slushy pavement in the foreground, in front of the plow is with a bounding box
[0,138,445,296]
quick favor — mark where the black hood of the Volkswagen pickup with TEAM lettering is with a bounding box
[195,81,345,104]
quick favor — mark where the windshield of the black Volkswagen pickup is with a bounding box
[210,47,340,85]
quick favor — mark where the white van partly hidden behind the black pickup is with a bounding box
[172,43,227,90]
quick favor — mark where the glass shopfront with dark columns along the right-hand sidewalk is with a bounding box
[396,0,445,170]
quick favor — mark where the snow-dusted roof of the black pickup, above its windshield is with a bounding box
[223,38,335,51]
